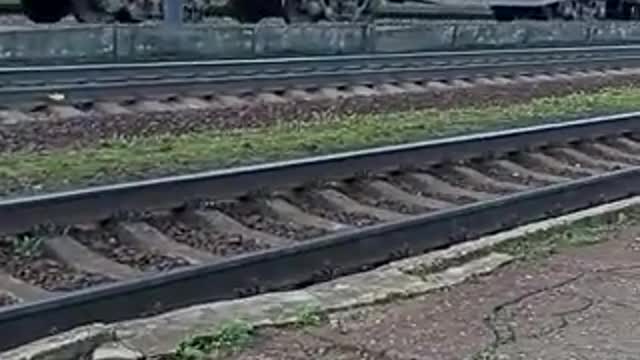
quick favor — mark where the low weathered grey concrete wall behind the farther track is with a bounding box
[0,21,640,64]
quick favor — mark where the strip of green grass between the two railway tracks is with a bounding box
[0,87,640,192]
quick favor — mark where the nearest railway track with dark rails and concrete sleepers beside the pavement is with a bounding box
[0,113,640,350]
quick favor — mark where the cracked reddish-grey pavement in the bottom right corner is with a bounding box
[229,221,640,360]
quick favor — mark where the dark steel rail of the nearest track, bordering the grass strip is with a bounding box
[0,112,640,234]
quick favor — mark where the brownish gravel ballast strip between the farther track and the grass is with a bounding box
[0,69,640,152]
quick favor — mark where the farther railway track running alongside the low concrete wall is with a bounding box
[6,45,640,124]
